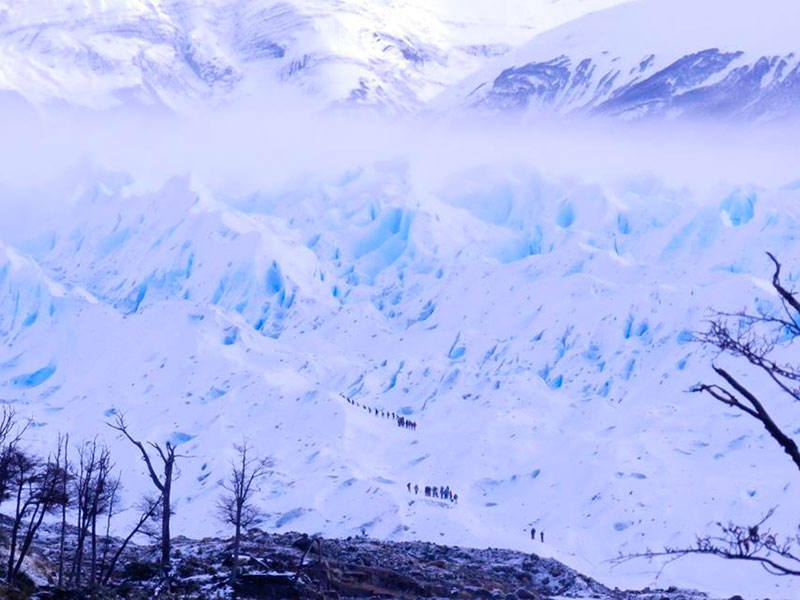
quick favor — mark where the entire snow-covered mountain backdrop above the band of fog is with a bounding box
[6,0,800,120]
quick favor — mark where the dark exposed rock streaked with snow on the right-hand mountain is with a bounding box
[471,48,800,120]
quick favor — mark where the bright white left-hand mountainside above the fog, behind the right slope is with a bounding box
[0,0,632,111]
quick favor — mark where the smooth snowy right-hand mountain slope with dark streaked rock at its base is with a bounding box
[432,0,800,120]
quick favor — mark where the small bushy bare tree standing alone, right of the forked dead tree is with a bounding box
[217,439,274,584]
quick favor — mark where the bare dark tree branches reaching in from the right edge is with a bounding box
[615,253,800,576]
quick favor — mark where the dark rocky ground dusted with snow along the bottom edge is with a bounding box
[0,530,724,600]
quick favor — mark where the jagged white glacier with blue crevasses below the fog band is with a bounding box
[0,162,800,598]
